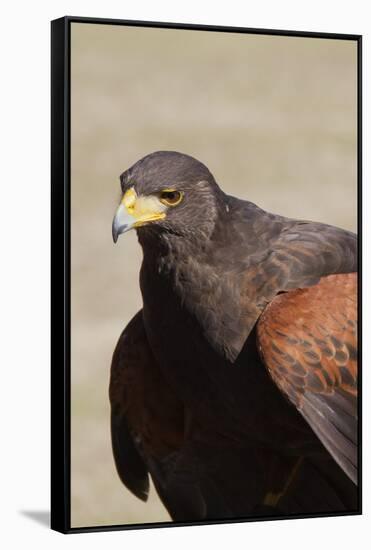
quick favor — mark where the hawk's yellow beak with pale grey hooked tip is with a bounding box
[112,187,166,242]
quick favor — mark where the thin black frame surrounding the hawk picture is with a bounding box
[51,16,362,533]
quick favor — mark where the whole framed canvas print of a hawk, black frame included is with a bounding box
[51,17,362,532]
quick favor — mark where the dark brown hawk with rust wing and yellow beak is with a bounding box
[110,151,358,521]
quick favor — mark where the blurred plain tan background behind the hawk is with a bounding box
[71,23,356,527]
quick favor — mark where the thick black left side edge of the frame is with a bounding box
[50,18,70,533]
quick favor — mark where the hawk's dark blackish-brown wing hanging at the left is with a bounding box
[109,311,184,505]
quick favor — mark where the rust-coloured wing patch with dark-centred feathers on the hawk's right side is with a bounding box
[257,273,357,481]
